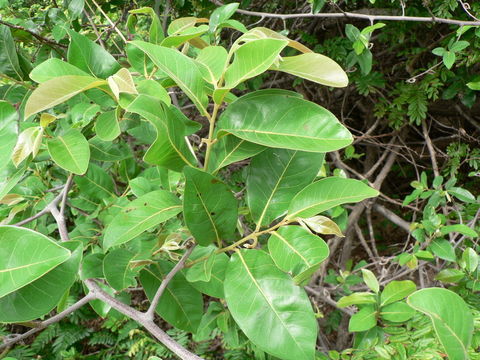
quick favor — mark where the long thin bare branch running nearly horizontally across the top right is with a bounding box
[211,0,480,26]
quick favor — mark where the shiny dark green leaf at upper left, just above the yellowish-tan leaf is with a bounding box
[67,30,120,79]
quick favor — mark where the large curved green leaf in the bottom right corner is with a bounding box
[407,288,473,360]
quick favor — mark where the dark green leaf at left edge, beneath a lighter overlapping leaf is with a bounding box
[0,241,83,323]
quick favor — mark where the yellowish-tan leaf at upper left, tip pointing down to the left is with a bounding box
[25,75,106,119]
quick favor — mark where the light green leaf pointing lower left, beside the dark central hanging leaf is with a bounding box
[103,190,182,248]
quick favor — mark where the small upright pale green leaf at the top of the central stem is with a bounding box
[195,46,228,85]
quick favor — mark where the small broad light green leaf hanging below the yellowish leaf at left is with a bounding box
[47,129,90,175]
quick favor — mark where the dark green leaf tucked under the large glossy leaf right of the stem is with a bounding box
[208,135,266,174]
